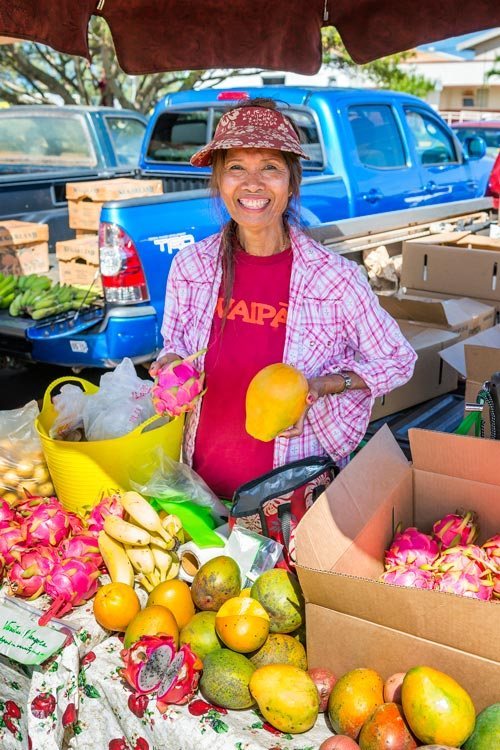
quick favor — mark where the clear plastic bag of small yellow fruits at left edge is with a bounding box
[0,401,54,504]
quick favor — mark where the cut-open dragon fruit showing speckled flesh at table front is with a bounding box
[120,635,202,713]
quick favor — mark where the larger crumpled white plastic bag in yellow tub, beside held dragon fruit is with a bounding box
[83,357,155,440]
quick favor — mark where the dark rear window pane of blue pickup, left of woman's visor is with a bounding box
[146,110,210,164]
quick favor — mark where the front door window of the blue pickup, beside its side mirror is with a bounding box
[405,107,458,166]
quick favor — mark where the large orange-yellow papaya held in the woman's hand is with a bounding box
[245,362,309,443]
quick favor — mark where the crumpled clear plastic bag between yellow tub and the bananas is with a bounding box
[130,448,229,523]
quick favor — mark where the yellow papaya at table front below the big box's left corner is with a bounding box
[249,664,319,734]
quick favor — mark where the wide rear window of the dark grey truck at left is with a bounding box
[0,113,97,168]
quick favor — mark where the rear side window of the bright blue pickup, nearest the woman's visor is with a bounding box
[348,104,406,169]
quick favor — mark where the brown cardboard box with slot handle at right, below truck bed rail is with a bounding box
[401,232,500,302]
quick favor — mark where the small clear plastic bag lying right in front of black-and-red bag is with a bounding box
[224,526,283,588]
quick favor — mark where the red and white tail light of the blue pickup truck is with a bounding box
[99,222,149,305]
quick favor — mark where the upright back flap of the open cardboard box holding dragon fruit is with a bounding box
[410,428,500,488]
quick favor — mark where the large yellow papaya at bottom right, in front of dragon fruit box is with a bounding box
[401,667,476,747]
